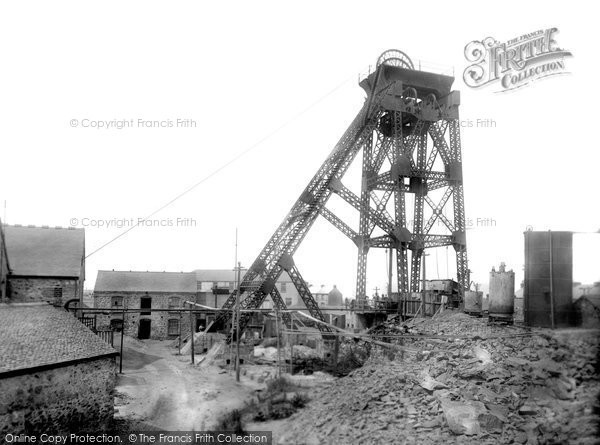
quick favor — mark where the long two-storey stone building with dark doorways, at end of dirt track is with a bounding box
[94,270,197,340]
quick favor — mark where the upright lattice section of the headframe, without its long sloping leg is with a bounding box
[327,86,469,302]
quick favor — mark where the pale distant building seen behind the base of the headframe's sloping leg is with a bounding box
[194,269,305,308]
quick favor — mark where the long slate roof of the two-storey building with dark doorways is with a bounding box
[94,270,197,293]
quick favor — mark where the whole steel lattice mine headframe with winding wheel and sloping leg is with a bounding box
[211,50,469,340]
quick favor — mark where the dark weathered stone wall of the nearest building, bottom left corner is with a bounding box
[0,357,116,436]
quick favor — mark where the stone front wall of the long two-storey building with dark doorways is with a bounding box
[94,292,196,340]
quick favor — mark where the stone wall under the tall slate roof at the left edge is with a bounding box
[8,277,80,306]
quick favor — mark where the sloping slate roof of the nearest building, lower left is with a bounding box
[0,303,118,375]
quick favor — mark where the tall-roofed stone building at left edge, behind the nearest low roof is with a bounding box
[4,225,85,306]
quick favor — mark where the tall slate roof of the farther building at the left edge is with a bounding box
[4,225,85,277]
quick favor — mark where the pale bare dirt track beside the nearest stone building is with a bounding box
[115,337,264,431]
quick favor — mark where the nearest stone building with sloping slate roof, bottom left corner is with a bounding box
[0,303,118,437]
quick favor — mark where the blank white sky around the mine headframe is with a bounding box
[0,1,600,296]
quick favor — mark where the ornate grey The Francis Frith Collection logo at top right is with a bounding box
[463,28,571,93]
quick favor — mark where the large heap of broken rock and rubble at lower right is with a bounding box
[278,313,600,444]
